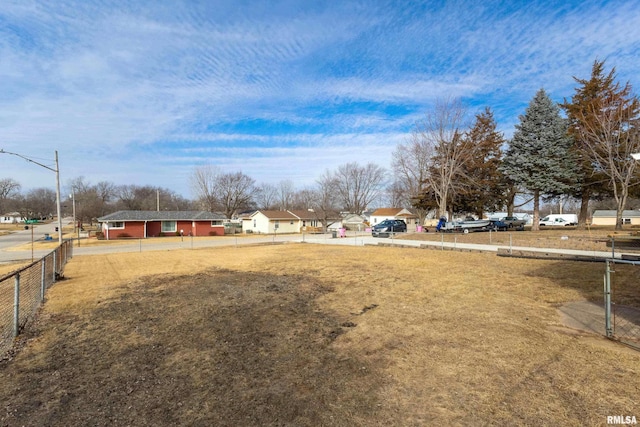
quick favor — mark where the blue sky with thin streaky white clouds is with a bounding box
[0,0,640,198]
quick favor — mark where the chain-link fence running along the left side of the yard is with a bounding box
[0,240,73,358]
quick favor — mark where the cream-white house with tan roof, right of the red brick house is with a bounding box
[242,210,322,234]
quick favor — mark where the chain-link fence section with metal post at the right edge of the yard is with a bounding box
[604,259,640,350]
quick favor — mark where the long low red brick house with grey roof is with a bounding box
[98,211,225,240]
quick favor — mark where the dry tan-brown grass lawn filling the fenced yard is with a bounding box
[0,244,640,426]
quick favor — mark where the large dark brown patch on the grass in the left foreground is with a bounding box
[0,270,384,426]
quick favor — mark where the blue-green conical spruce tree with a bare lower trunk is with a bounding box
[501,89,579,230]
